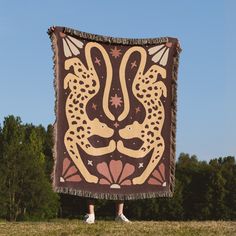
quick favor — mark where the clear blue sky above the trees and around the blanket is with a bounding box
[0,0,236,160]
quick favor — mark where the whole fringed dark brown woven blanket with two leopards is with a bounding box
[48,27,181,200]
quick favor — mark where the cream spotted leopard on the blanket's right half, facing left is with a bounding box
[117,46,167,184]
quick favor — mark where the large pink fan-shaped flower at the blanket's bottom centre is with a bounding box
[97,160,134,188]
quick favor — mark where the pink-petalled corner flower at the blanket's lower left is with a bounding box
[60,158,81,183]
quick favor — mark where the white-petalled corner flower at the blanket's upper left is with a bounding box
[60,32,84,57]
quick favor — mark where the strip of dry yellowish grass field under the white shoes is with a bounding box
[0,220,236,236]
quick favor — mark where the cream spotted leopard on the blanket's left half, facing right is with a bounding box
[64,42,116,183]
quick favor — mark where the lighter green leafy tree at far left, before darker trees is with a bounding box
[0,116,58,221]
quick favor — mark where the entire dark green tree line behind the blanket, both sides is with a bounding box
[0,116,236,221]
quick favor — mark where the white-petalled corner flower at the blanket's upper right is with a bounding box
[148,42,172,66]
